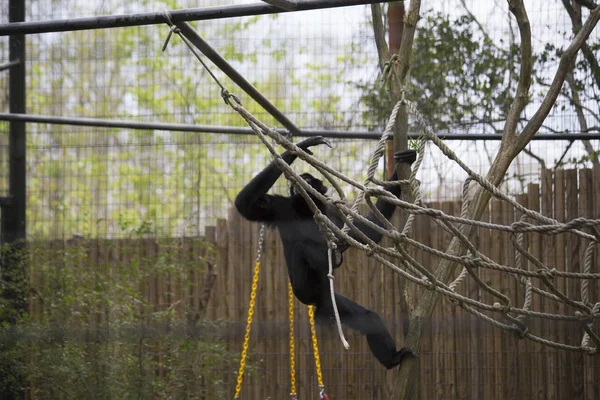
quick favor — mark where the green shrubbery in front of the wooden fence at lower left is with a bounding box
[0,239,238,399]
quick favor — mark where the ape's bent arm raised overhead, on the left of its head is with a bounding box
[235,136,329,222]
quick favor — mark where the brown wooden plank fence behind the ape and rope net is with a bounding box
[25,169,600,400]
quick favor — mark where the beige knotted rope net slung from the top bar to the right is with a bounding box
[165,18,600,355]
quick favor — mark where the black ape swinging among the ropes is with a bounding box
[235,137,416,369]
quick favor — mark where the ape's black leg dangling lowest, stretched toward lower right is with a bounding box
[316,291,414,369]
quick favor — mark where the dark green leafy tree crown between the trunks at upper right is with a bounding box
[360,11,519,131]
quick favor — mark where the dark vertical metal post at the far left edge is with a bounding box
[0,0,27,244]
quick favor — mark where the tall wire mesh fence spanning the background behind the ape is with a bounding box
[0,0,600,399]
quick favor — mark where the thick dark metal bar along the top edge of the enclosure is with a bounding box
[0,0,380,36]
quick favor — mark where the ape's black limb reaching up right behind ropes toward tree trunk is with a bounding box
[332,150,417,252]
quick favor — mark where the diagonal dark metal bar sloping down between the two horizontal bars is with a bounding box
[176,22,300,135]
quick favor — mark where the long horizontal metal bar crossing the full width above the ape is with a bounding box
[0,113,600,140]
